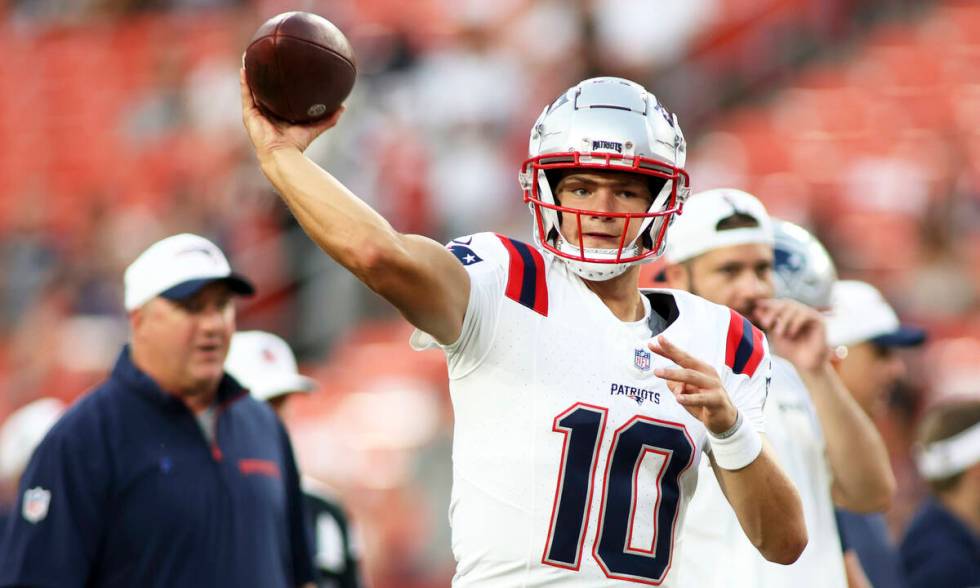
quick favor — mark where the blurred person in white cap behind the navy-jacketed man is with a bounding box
[225,331,363,588]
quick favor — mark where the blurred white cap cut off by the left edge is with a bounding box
[0,398,65,480]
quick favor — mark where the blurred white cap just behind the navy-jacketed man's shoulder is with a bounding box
[225,331,317,400]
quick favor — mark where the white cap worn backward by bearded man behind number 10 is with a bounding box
[665,188,774,263]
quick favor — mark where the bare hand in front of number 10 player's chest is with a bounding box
[647,335,738,435]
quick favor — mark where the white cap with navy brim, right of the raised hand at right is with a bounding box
[827,280,926,347]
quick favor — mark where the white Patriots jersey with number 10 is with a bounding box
[413,233,770,587]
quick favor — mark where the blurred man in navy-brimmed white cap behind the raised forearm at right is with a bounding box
[827,280,926,587]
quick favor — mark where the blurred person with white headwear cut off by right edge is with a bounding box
[901,398,980,588]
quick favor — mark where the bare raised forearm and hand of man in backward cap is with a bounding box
[756,300,895,512]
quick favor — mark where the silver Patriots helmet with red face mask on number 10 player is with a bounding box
[519,77,690,281]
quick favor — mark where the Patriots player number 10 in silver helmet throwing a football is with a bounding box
[242,71,806,587]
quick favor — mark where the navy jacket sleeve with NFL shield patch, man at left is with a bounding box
[0,413,109,588]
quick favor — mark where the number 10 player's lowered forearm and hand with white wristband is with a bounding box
[649,336,807,564]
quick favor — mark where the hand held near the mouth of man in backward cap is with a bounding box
[752,298,830,371]
